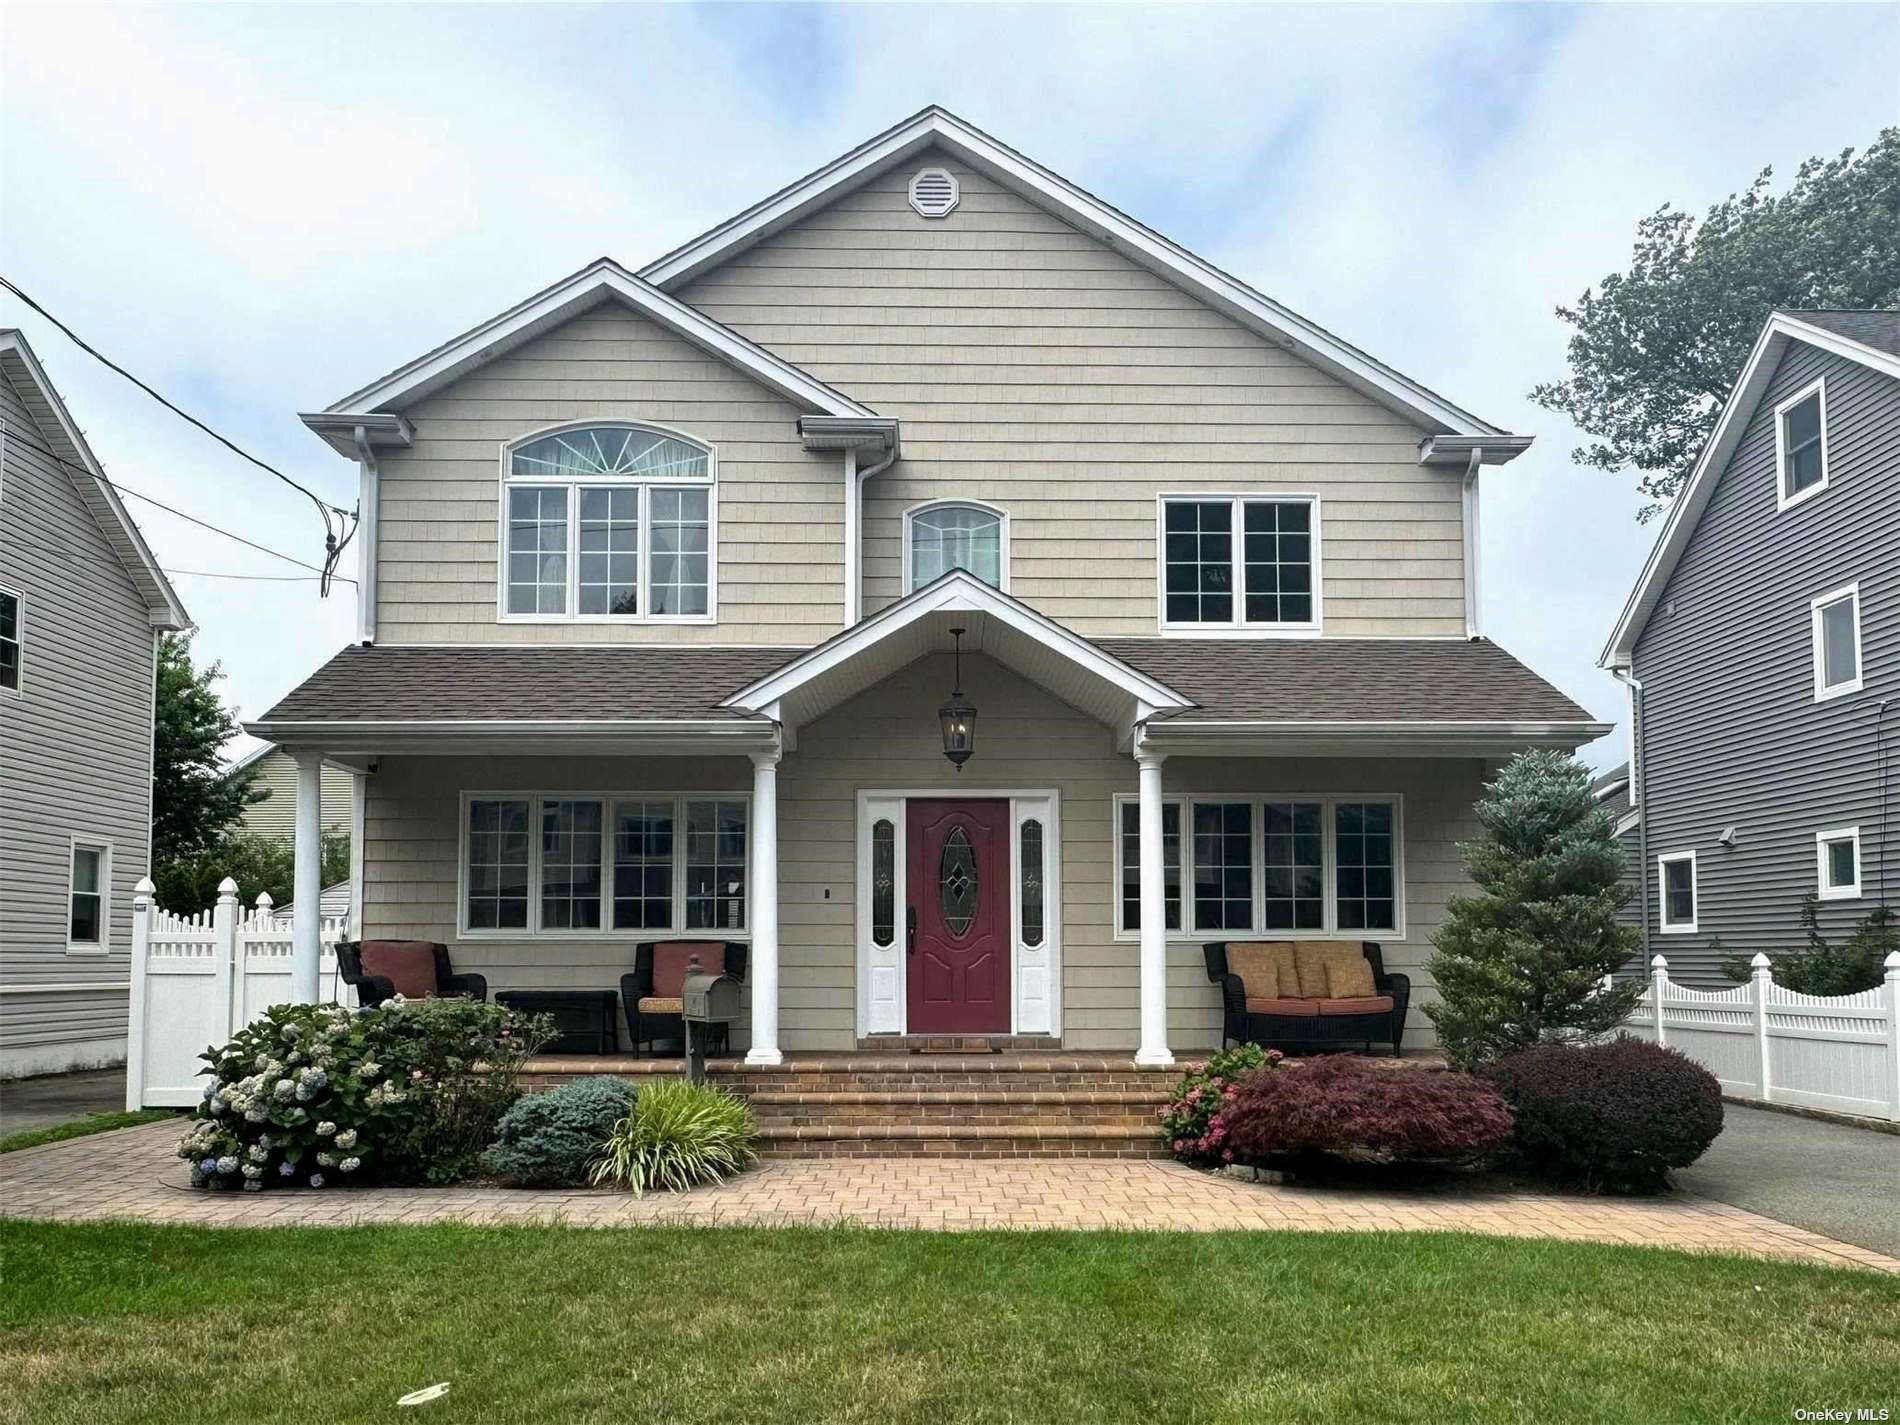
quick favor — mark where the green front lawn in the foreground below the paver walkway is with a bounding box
[0,1222,1900,1425]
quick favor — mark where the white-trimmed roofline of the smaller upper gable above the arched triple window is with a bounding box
[306,257,876,424]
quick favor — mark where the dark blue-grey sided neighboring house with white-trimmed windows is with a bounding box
[1602,312,1900,986]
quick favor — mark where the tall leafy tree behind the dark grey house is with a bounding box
[1531,129,1900,521]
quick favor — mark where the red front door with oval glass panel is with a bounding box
[904,800,1009,1034]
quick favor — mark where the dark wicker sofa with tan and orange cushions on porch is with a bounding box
[1201,941,1412,1055]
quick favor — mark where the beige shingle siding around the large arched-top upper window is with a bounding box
[376,304,844,644]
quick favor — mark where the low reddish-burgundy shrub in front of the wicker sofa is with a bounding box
[1214,1055,1511,1167]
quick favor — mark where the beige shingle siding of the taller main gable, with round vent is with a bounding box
[682,156,1465,635]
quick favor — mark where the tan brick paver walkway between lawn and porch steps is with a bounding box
[0,1123,1900,1273]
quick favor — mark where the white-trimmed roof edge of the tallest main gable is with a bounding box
[640,105,1528,446]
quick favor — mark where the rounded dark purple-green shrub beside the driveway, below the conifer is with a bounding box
[1486,1036,1721,1193]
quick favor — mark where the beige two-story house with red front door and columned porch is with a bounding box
[251,108,1607,1071]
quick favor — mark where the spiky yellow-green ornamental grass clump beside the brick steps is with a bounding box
[593,1079,758,1197]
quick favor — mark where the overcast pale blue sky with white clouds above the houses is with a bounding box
[0,4,1900,766]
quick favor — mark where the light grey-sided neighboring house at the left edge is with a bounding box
[0,331,190,1077]
